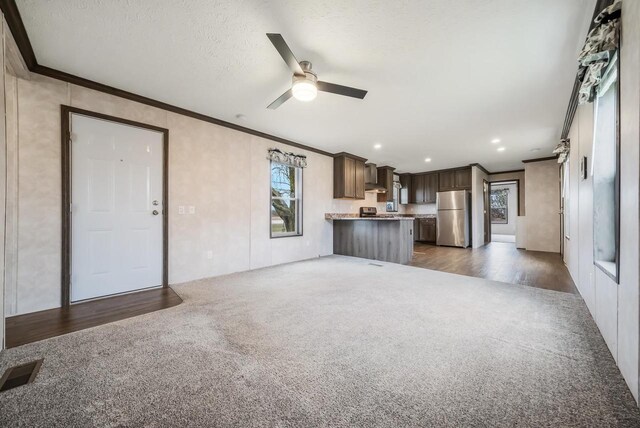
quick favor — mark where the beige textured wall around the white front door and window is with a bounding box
[6,75,333,314]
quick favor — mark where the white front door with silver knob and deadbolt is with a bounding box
[71,114,164,302]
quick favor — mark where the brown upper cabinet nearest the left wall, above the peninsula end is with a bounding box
[333,152,366,199]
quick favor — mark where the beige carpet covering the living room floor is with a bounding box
[0,256,640,427]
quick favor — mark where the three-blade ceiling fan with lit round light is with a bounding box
[267,33,367,110]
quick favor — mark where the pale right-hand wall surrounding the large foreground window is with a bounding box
[565,1,640,400]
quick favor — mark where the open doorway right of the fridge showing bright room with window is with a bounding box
[489,180,520,245]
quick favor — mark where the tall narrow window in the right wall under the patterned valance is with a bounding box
[591,51,620,282]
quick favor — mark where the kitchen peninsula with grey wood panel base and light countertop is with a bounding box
[325,214,414,264]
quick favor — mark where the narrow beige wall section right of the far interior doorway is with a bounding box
[525,159,560,253]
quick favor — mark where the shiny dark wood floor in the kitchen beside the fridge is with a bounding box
[409,242,578,293]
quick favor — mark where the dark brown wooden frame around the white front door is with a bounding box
[60,104,169,308]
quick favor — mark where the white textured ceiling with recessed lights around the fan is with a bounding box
[17,0,595,172]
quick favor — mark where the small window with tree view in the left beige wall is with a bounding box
[271,161,302,238]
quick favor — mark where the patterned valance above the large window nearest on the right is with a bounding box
[578,0,622,104]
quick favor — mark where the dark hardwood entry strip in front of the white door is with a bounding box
[6,287,182,348]
